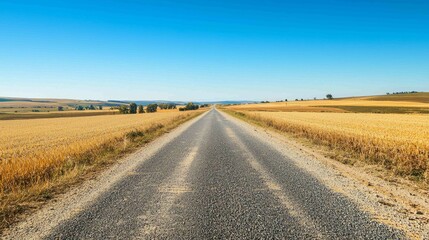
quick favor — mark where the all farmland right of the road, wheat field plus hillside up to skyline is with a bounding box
[222,93,429,182]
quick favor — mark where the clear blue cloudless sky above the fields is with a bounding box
[0,0,429,101]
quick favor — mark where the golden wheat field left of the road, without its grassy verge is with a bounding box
[0,111,195,192]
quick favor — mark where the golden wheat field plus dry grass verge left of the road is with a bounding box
[0,110,201,229]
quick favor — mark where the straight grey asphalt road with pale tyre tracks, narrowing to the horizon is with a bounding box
[47,109,403,239]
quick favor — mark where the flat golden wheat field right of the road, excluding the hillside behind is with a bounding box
[224,112,429,182]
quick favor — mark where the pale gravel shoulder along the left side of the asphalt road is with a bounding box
[0,110,211,239]
